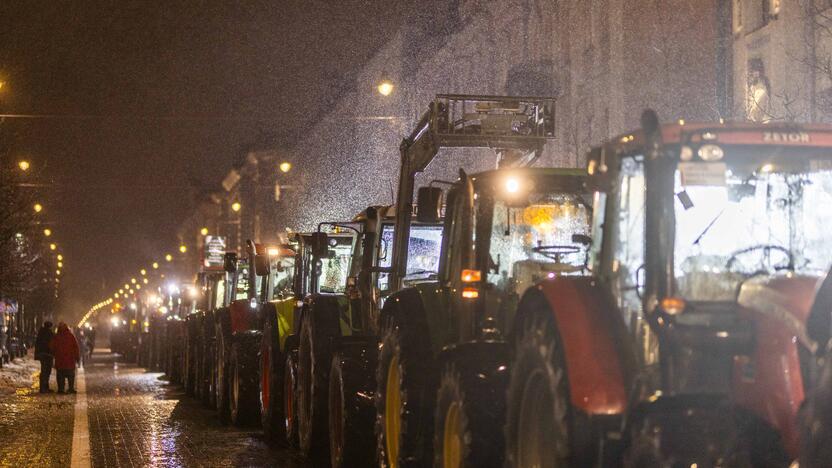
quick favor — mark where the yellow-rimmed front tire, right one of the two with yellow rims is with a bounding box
[433,342,509,468]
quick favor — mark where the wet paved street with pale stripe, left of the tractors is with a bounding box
[0,352,316,468]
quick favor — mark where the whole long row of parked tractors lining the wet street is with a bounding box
[128,95,832,467]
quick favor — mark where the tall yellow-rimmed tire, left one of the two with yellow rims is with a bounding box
[375,313,437,468]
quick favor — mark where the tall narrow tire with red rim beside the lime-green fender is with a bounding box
[260,316,286,443]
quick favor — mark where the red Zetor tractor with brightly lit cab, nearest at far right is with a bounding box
[505,111,832,467]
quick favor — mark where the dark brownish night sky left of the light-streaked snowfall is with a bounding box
[0,0,406,316]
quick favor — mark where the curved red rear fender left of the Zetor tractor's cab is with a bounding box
[515,277,636,416]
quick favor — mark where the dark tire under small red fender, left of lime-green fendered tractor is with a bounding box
[229,331,262,426]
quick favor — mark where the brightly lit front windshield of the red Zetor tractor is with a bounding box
[674,162,832,301]
